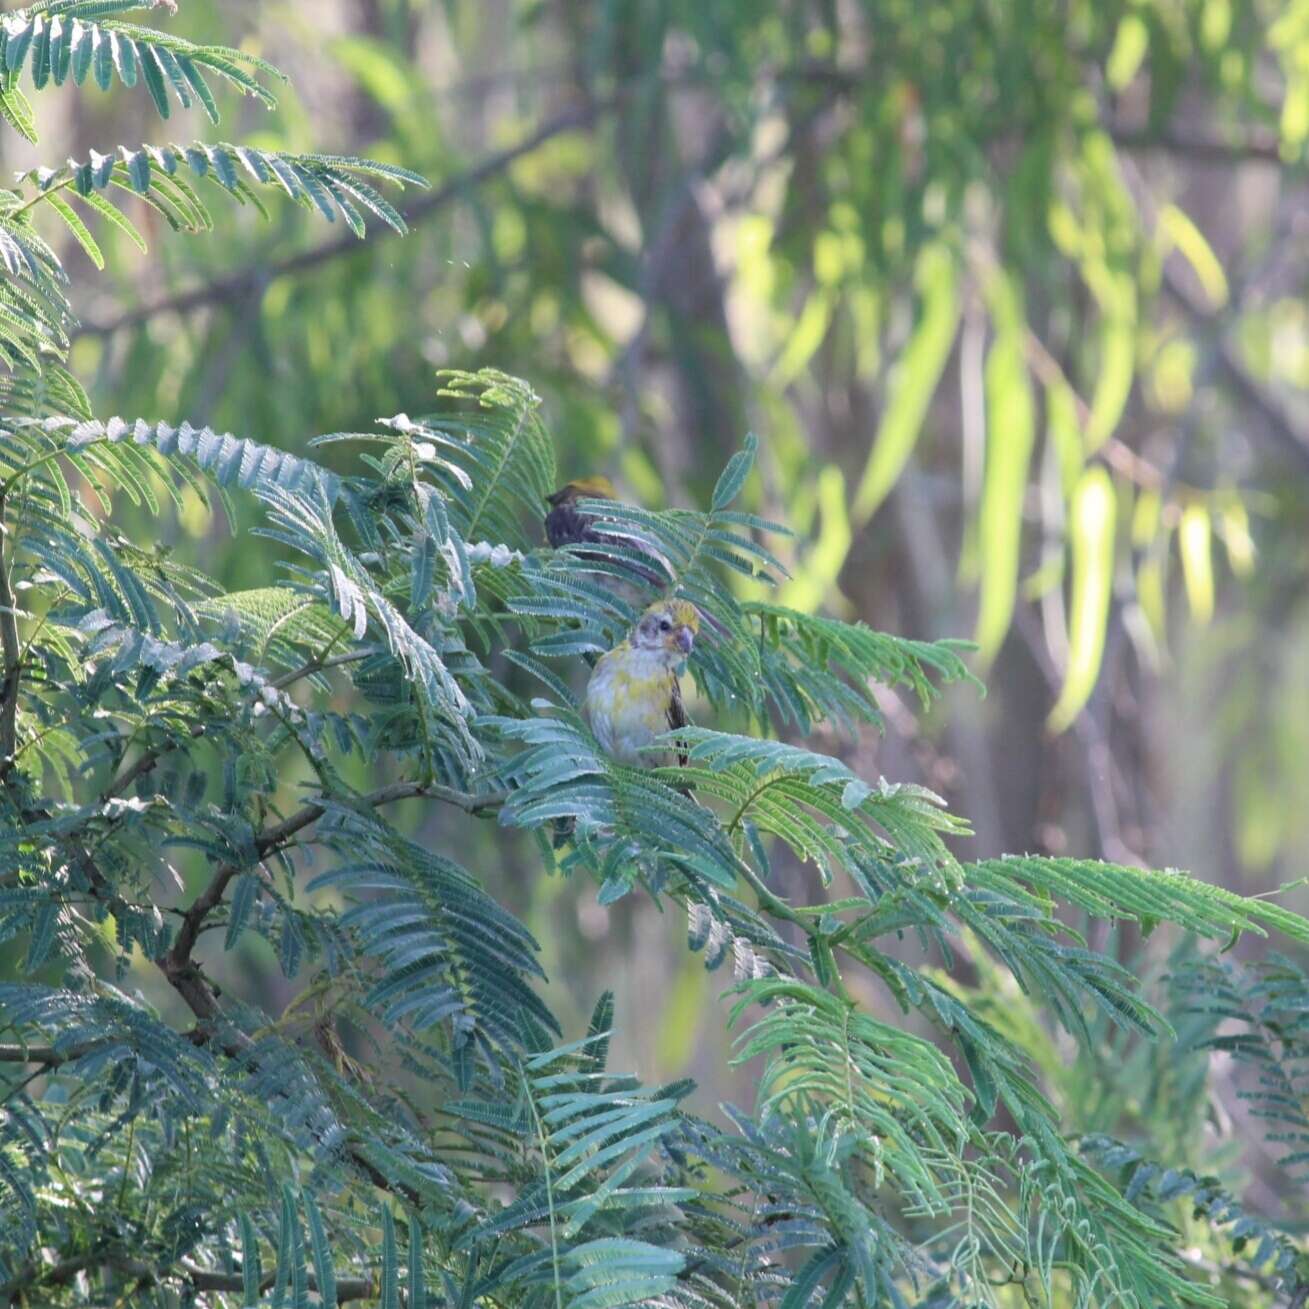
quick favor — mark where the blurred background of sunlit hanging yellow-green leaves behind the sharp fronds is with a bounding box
[0,0,1309,1277]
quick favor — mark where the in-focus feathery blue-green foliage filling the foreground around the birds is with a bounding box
[0,0,1309,1309]
